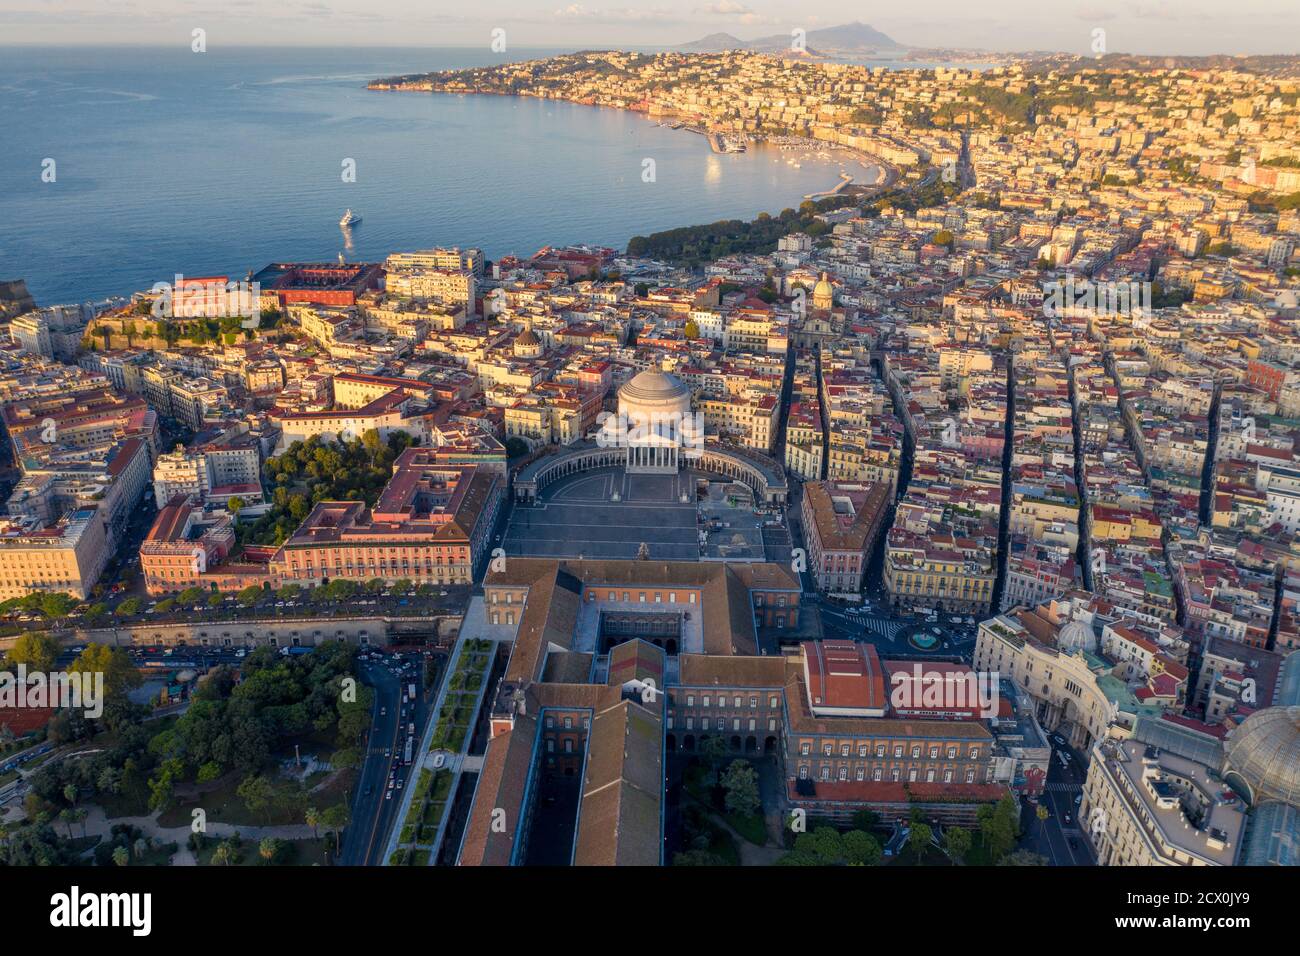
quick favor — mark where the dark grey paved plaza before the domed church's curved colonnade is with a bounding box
[502,468,769,561]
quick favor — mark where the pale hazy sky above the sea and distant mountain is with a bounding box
[0,0,1300,55]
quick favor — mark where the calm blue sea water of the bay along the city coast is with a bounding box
[0,47,868,304]
